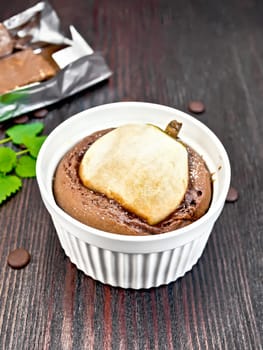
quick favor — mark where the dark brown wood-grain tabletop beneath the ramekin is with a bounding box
[0,0,263,350]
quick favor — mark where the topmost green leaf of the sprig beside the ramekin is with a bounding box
[6,123,44,145]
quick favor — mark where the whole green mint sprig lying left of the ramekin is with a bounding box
[0,123,46,204]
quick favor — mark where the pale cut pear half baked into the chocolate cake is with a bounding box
[79,124,188,225]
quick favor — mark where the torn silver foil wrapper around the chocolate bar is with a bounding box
[0,2,112,122]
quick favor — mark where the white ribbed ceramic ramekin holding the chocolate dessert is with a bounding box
[37,102,230,289]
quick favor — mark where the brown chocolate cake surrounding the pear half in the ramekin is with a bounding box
[53,124,212,235]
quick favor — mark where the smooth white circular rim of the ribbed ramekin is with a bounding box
[36,101,231,243]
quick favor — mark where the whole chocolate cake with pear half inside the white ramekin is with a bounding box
[54,121,212,235]
